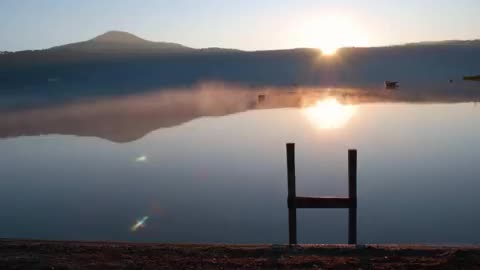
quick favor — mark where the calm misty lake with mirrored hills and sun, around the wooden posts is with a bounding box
[0,83,480,244]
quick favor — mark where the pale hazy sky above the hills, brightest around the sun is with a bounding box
[0,0,480,51]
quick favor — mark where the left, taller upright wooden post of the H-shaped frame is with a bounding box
[287,143,297,245]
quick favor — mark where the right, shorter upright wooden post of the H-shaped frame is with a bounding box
[348,150,357,245]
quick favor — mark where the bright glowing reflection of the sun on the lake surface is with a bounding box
[303,98,357,129]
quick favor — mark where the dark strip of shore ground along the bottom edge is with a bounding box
[0,239,480,269]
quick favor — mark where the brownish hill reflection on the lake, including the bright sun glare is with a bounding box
[0,82,480,142]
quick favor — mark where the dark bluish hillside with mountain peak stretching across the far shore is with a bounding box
[0,32,480,95]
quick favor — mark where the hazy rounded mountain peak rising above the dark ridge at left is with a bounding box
[49,31,193,53]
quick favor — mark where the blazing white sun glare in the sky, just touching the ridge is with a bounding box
[298,15,368,56]
